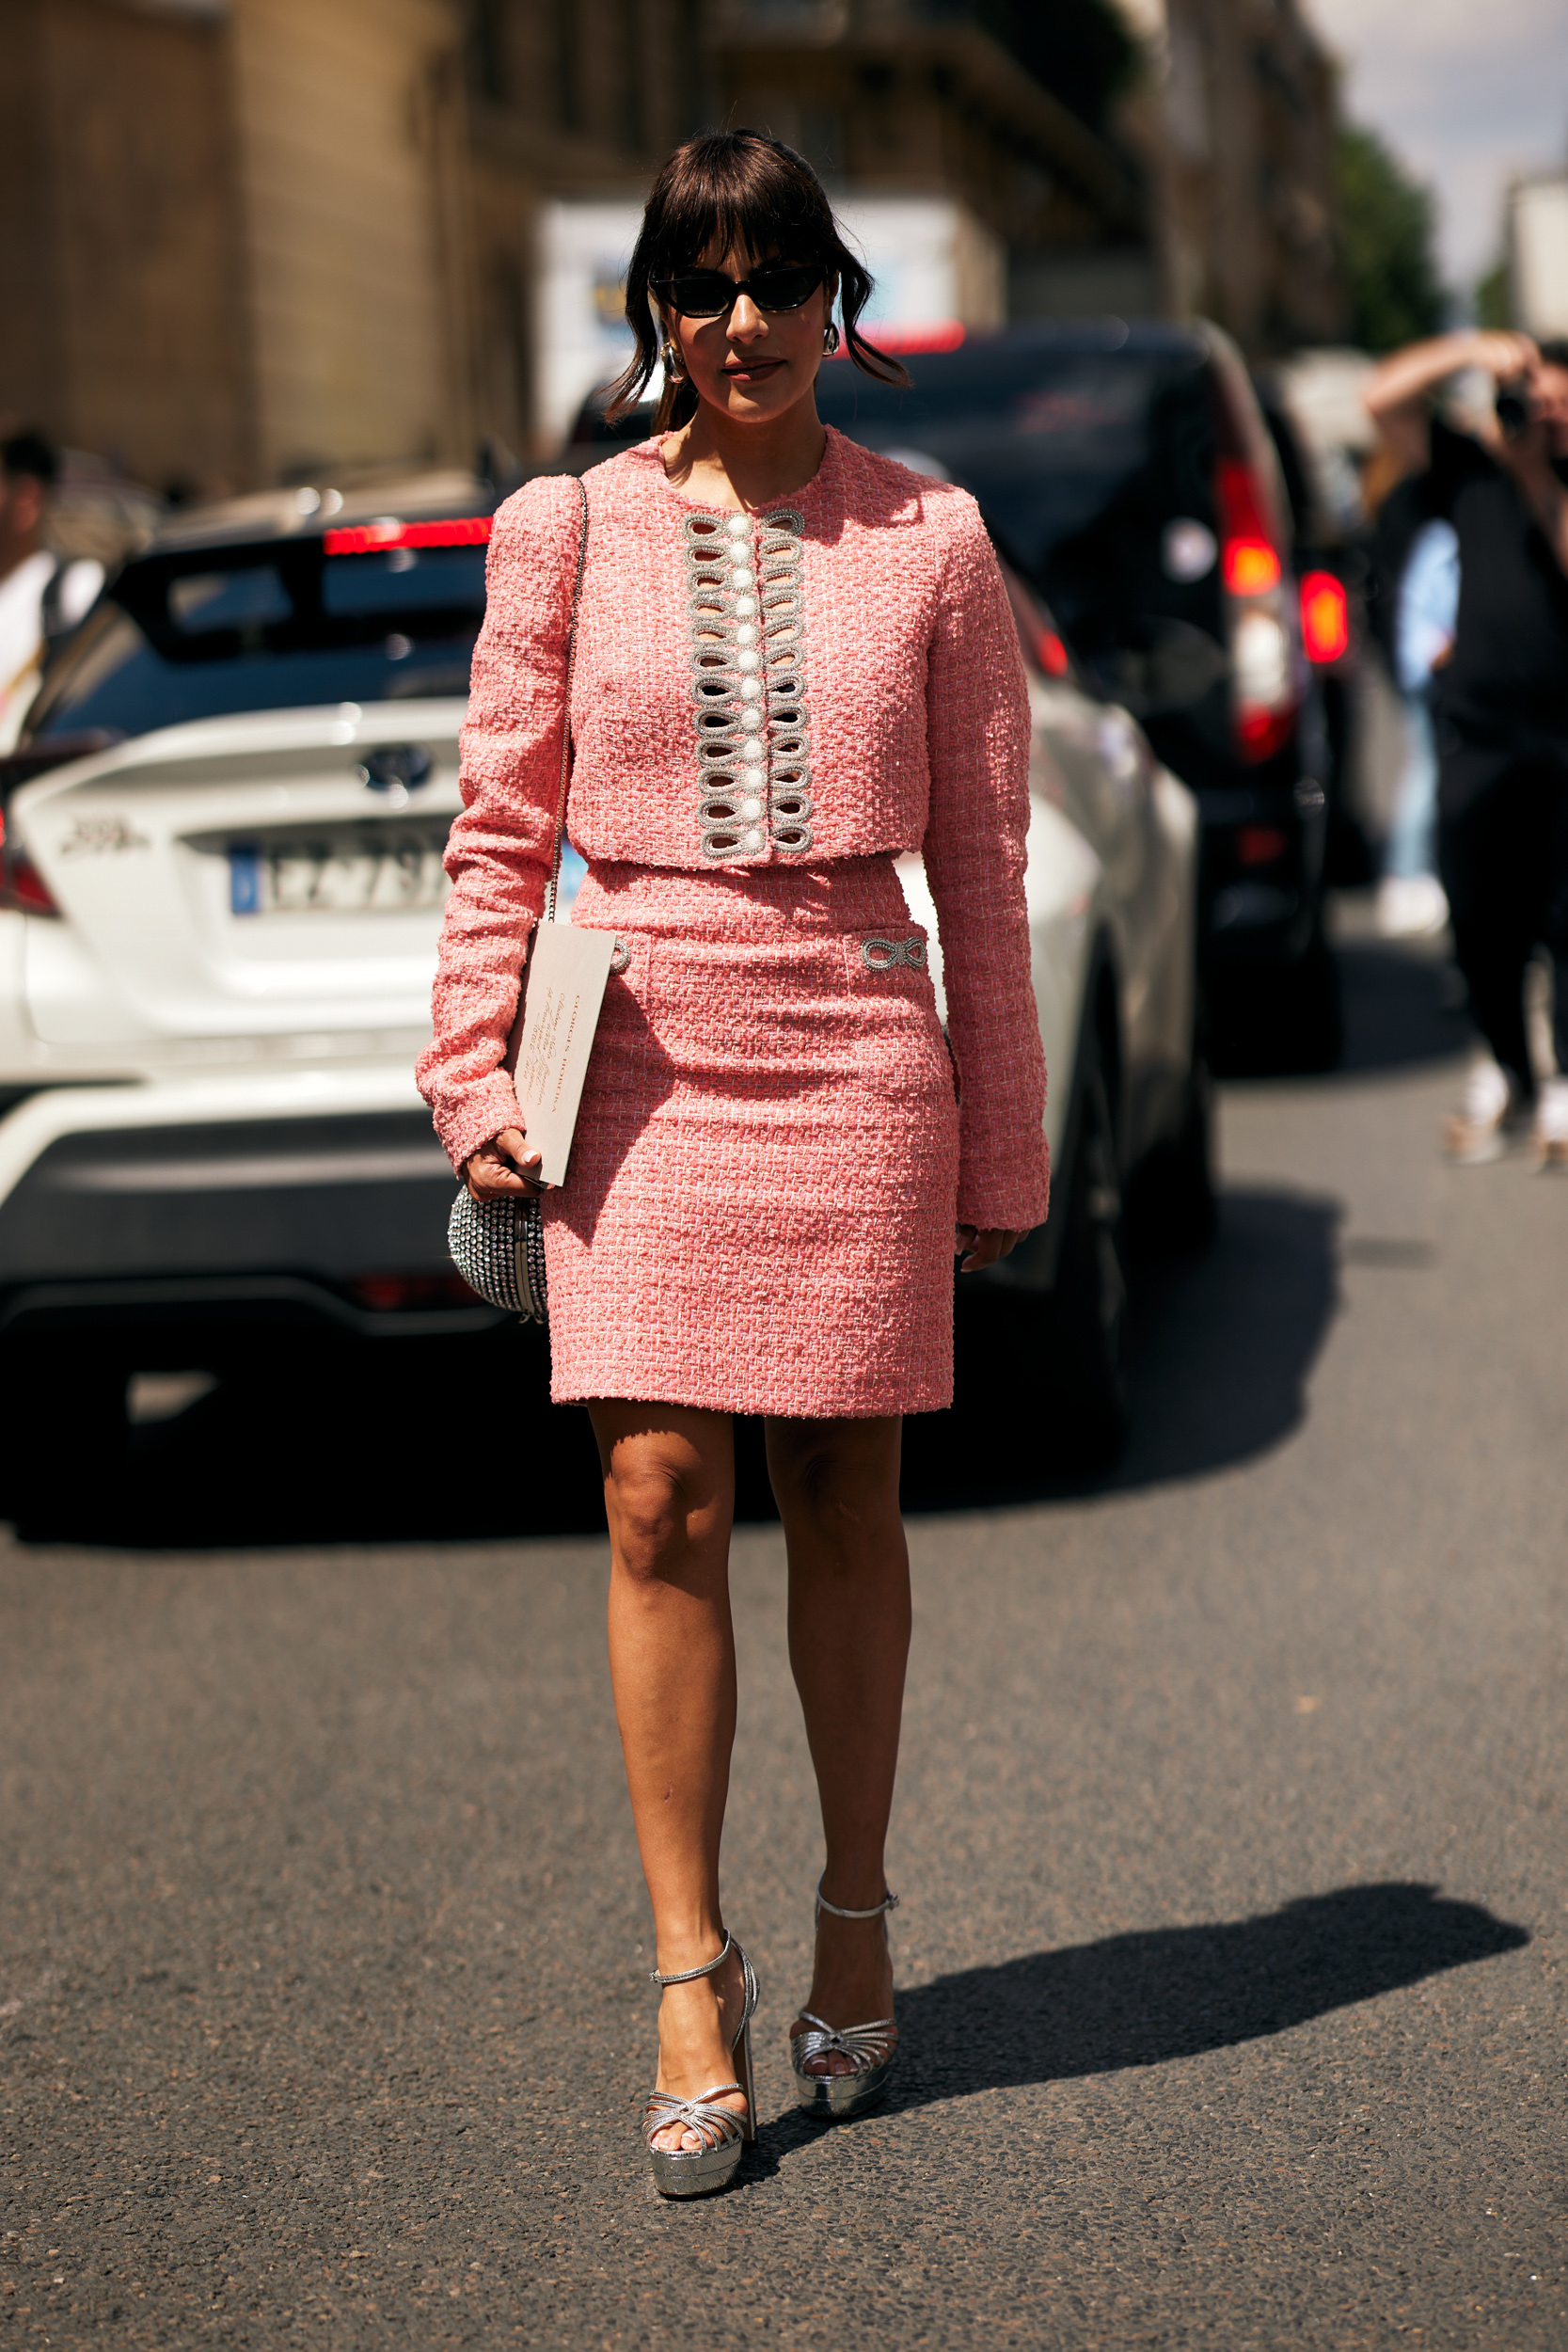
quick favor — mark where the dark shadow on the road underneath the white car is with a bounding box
[0,1185,1338,1550]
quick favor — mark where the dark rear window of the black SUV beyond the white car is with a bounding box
[818,325,1220,691]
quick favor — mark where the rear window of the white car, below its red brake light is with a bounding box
[28,539,484,741]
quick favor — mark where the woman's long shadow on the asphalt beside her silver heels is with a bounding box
[757,1882,1530,2164]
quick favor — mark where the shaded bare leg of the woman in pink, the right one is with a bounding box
[767,1416,910,2074]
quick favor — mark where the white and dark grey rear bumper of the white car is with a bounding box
[0,1071,503,1339]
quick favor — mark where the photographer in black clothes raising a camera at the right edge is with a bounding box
[1364,332,1568,1167]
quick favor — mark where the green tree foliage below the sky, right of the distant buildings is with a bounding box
[1336,122,1449,351]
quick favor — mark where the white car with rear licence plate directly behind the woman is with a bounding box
[0,478,1206,1505]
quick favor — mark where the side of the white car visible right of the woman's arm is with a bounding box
[905,563,1215,1468]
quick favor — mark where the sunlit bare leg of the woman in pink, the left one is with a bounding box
[588,1400,745,2150]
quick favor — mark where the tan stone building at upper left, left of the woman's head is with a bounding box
[0,0,703,492]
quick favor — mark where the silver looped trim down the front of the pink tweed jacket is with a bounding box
[684,506,814,864]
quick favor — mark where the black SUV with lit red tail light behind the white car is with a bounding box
[818,320,1338,1063]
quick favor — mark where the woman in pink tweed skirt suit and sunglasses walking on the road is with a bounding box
[420,132,1046,2197]
